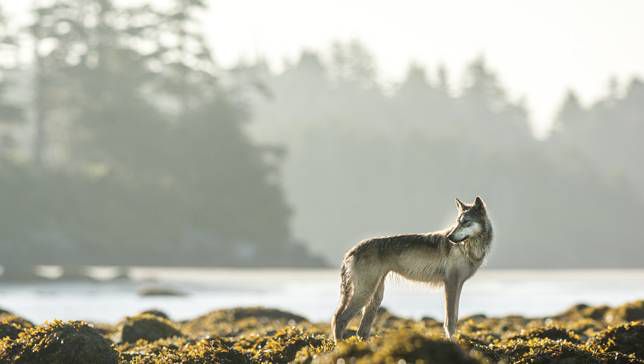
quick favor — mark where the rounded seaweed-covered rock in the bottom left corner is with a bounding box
[0,321,118,364]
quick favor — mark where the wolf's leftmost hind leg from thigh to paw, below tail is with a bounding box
[332,272,378,341]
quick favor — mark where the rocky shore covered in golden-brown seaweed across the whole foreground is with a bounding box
[0,300,644,364]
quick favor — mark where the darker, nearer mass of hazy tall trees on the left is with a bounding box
[0,0,322,273]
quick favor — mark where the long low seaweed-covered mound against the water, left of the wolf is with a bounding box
[182,307,307,336]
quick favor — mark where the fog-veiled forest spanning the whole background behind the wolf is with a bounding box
[0,0,644,279]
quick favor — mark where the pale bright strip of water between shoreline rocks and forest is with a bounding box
[0,269,644,322]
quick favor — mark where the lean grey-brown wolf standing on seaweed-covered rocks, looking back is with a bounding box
[331,197,492,341]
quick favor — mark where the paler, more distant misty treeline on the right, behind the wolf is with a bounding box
[238,42,644,268]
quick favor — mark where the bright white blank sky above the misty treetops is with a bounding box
[5,0,644,135]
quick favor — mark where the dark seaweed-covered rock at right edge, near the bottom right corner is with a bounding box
[588,321,644,360]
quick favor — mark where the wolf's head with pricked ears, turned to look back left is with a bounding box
[447,197,488,243]
